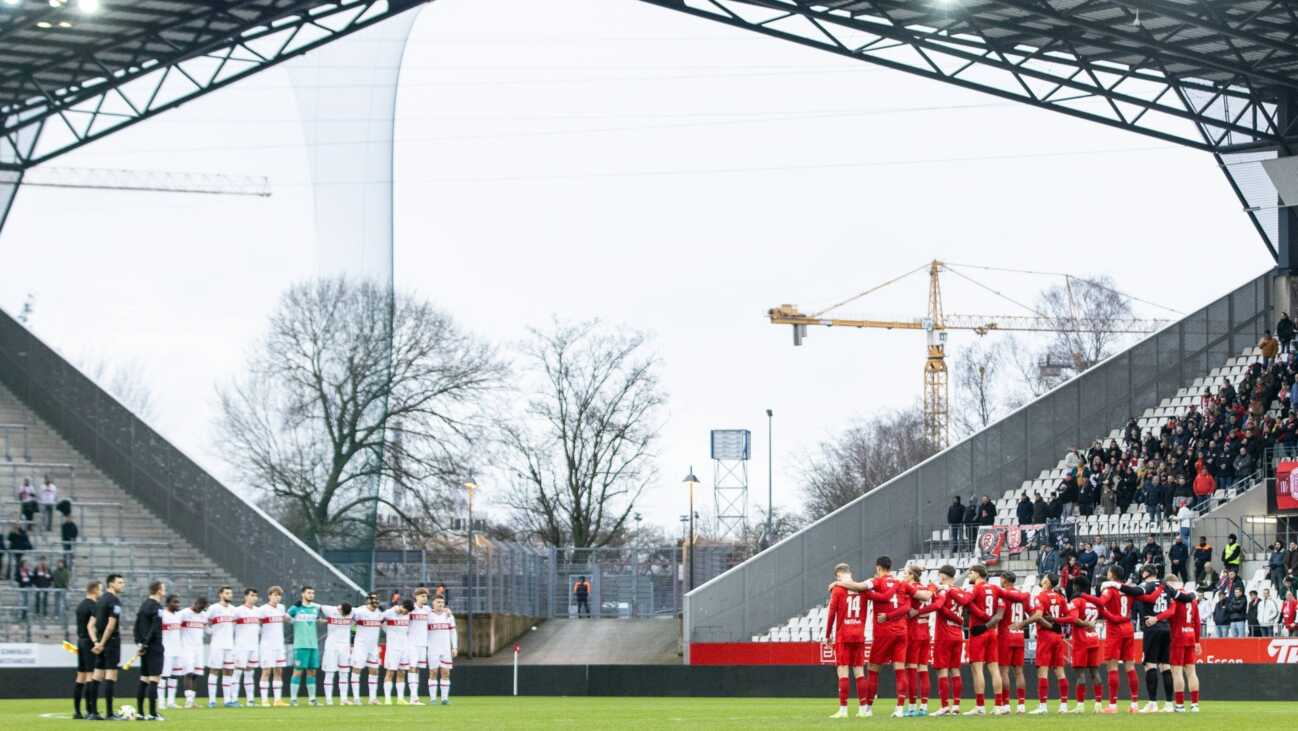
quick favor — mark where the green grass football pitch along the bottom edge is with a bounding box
[0,696,1298,731]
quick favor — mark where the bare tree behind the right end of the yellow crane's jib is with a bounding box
[1037,275,1133,373]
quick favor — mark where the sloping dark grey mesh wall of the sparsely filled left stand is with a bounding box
[0,307,361,596]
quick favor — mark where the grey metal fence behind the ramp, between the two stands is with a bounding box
[326,541,748,618]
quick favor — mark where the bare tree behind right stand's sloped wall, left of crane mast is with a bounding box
[801,408,937,518]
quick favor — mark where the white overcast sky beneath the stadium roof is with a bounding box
[0,0,1271,537]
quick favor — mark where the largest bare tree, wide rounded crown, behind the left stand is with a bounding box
[217,278,506,547]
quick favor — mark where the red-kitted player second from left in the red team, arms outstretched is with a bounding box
[836,556,928,718]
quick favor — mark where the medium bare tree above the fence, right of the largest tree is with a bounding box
[501,321,666,548]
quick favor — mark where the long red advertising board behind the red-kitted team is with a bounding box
[689,638,1298,665]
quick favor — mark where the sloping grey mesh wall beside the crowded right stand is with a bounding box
[684,273,1273,652]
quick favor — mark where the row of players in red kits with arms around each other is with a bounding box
[824,556,1199,718]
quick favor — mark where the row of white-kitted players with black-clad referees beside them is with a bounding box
[77,575,458,719]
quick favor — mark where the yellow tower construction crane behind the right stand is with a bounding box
[767,260,1167,449]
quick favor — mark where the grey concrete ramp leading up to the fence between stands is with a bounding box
[474,617,681,665]
